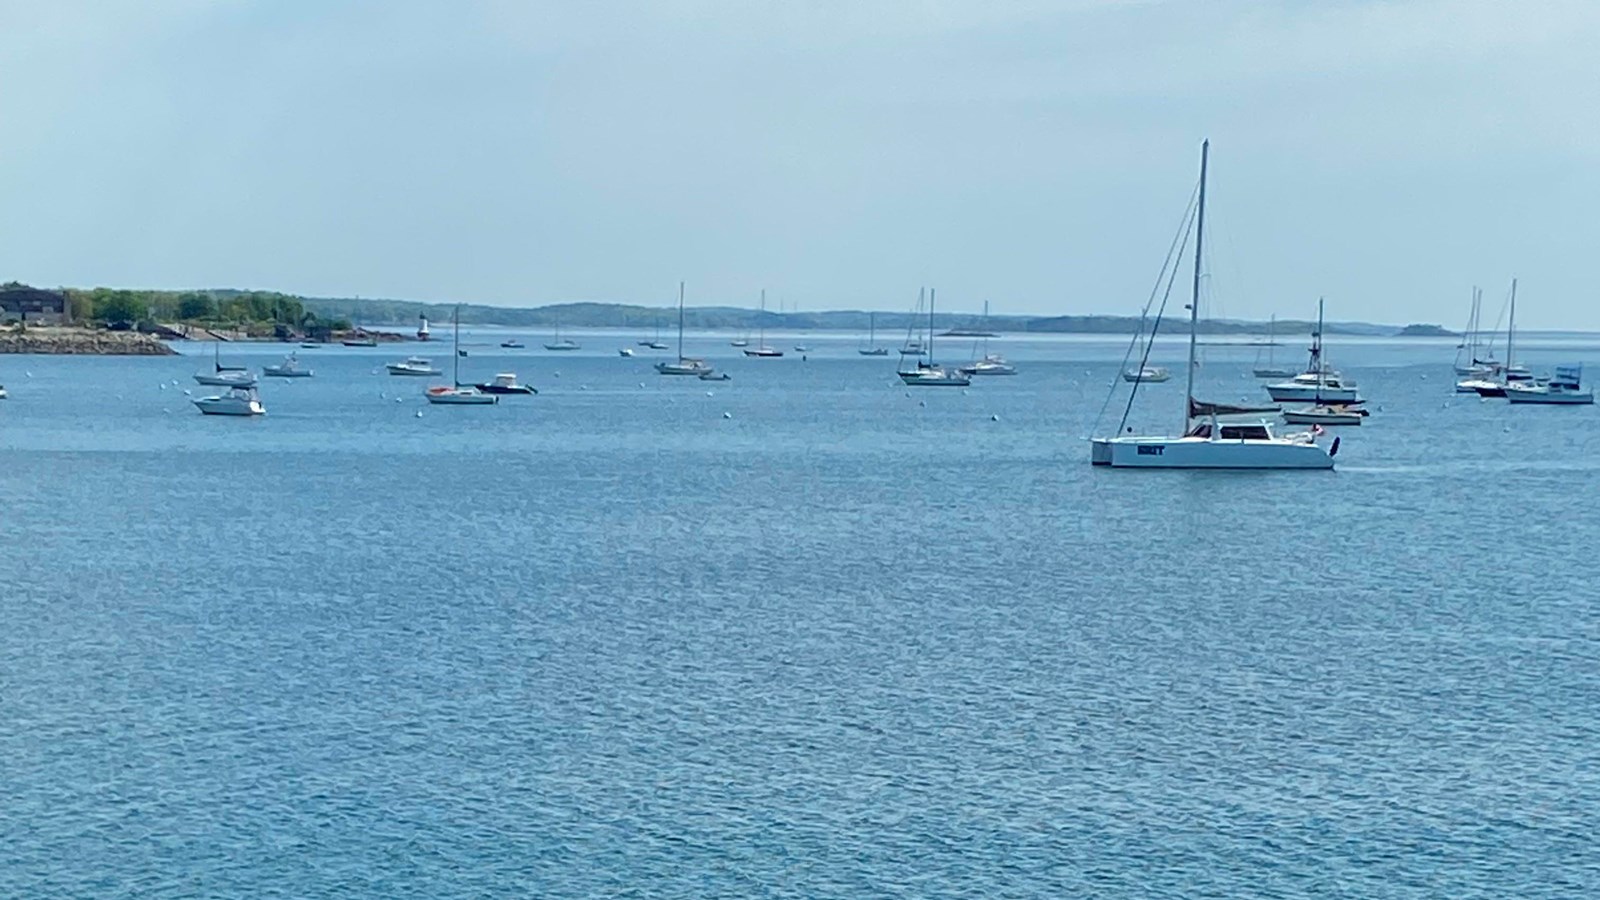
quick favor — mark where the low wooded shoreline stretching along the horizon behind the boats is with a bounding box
[0,282,1453,341]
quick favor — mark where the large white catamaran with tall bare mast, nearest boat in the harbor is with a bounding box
[1090,141,1339,469]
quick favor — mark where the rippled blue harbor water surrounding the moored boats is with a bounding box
[0,335,1600,897]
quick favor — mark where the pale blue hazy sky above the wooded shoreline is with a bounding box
[0,0,1600,328]
